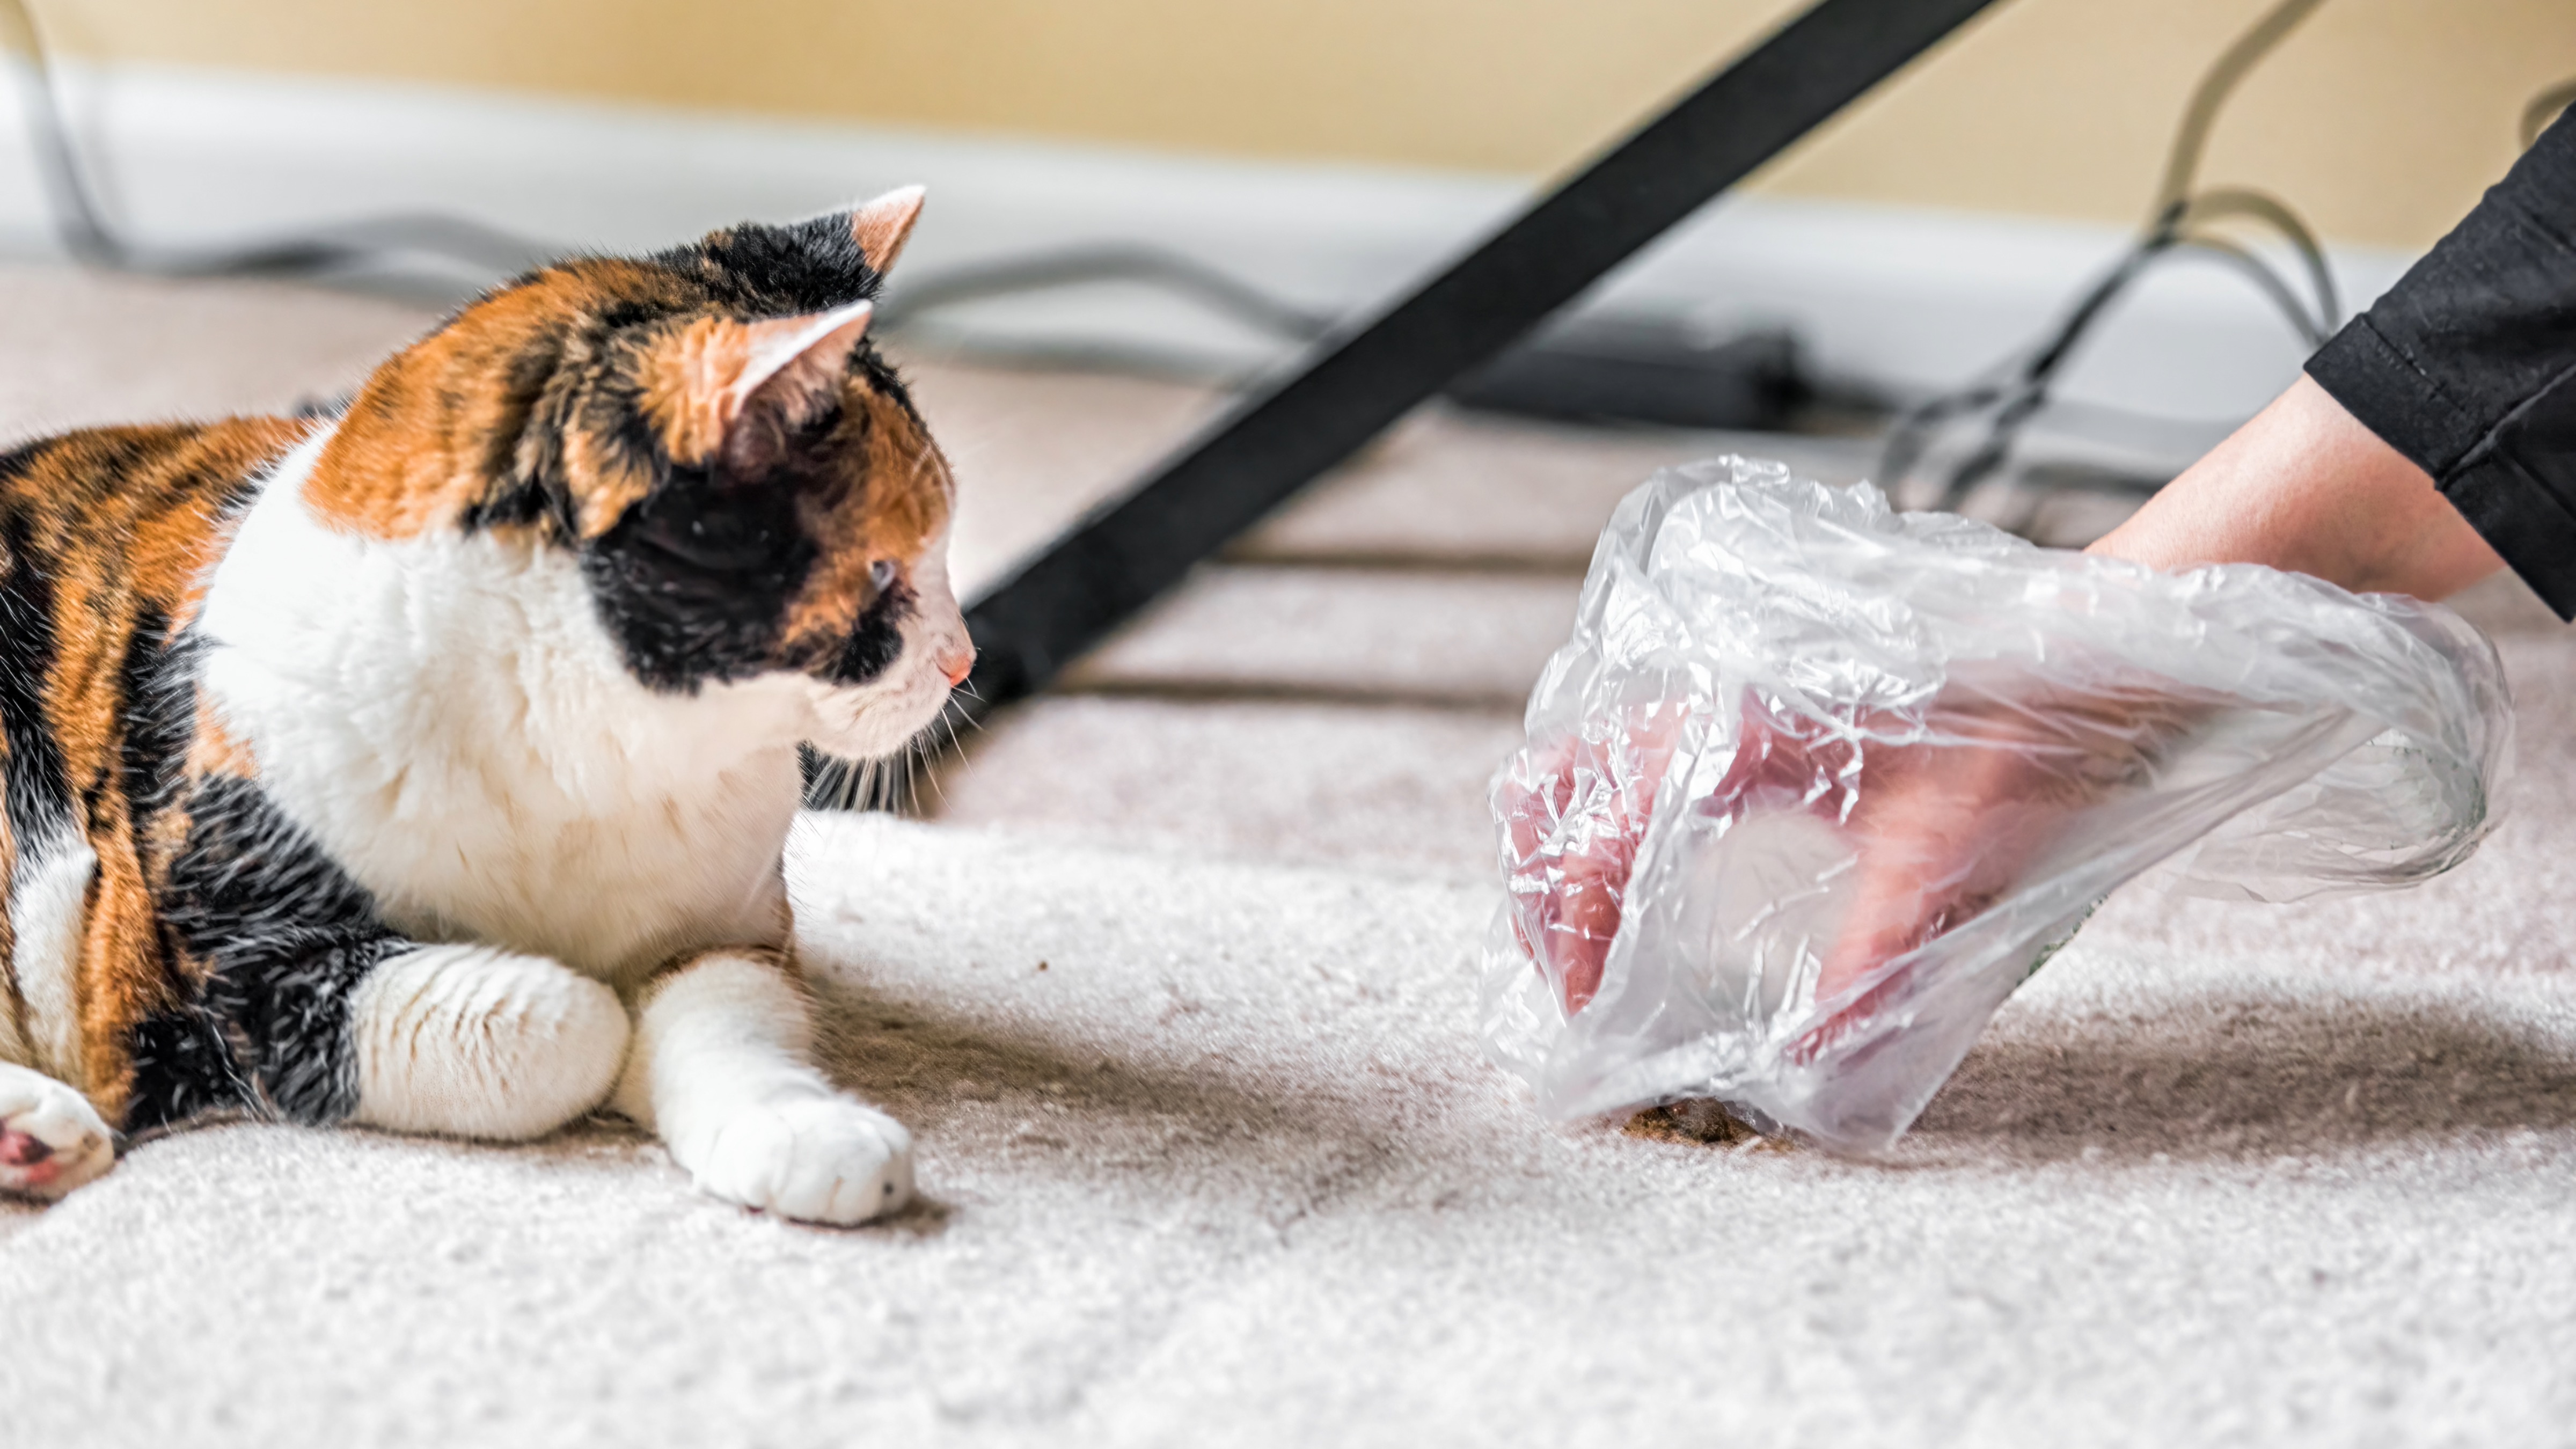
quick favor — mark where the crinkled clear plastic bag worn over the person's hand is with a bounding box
[1487,459,2512,1155]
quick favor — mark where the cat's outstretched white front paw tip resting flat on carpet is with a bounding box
[683,1093,912,1227]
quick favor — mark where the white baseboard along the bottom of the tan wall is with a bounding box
[0,67,2409,451]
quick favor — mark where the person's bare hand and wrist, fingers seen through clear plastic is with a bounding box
[1497,376,2504,1055]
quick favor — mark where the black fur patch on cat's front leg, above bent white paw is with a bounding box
[129,776,409,1129]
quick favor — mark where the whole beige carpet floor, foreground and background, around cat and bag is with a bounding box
[0,261,2576,1449]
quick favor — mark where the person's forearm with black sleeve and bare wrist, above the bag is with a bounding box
[2097,113,2576,603]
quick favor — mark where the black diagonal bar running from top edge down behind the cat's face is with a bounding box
[966,0,1994,714]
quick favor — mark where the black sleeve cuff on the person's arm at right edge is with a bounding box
[2308,111,2576,619]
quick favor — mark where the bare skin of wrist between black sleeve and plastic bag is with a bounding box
[2089,376,2504,598]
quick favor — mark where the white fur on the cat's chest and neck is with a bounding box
[201,422,811,985]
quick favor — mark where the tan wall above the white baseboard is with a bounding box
[36,0,2576,247]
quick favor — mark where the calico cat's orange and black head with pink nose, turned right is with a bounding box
[304,188,974,758]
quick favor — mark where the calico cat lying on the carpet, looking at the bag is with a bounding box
[0,188,974,1222]
